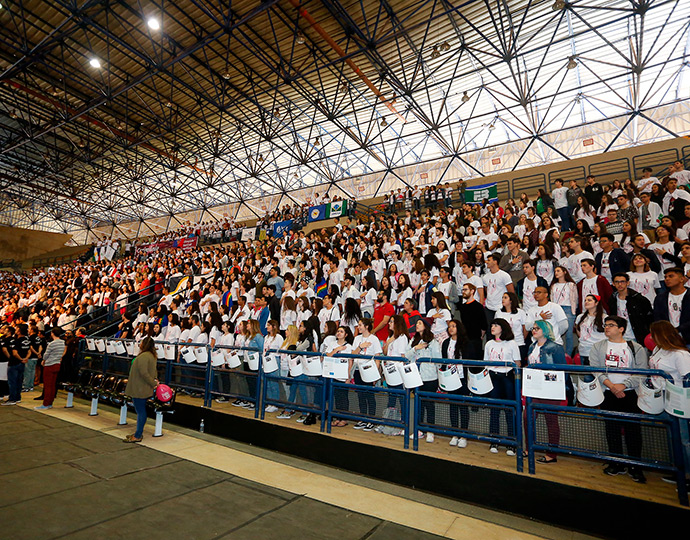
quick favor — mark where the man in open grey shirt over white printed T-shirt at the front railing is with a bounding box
[589,315,649,484]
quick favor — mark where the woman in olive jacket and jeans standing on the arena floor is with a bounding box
[124,337,158,443]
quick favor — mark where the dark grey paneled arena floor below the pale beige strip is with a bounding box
[0,407,440,540]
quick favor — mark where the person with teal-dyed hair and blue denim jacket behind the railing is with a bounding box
[527,320,570,463]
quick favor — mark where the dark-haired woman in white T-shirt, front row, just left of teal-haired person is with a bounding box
[484,318,521,456]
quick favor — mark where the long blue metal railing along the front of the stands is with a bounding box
[75,337,688,506]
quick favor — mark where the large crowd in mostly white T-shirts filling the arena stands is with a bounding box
[0,162,690,482]
